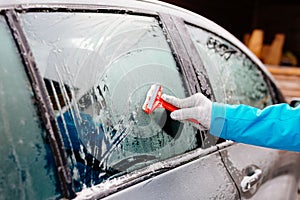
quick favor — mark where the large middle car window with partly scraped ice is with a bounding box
[20,13,202,190]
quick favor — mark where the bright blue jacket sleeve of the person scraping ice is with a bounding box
[210,103,300,152]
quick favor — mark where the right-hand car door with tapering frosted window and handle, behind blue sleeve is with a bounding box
[185,18,299,199]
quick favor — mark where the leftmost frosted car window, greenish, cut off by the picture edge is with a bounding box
[0,16,60,199]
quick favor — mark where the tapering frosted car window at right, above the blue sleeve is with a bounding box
[187,25,272,108]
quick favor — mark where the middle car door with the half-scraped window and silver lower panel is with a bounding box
[15,5,238,199]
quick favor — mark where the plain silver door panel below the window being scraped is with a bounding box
[77,148,239,200]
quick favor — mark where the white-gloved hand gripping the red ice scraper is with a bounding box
[162,93,212,129]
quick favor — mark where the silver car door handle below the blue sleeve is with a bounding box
[241,168,263,192]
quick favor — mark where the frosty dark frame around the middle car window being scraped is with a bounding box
[4,4,225,198]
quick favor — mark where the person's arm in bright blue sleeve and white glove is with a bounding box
[164,93,300,151]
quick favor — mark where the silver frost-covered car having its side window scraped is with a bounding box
[0,0,300,200]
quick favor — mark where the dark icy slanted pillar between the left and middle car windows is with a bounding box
[3,9,75,198]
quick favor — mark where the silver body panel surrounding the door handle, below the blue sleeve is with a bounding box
[220,143,300,199]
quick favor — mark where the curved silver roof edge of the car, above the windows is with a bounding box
[0,0,276,82]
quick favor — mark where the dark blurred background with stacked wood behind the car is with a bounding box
[163,0,300,101]
